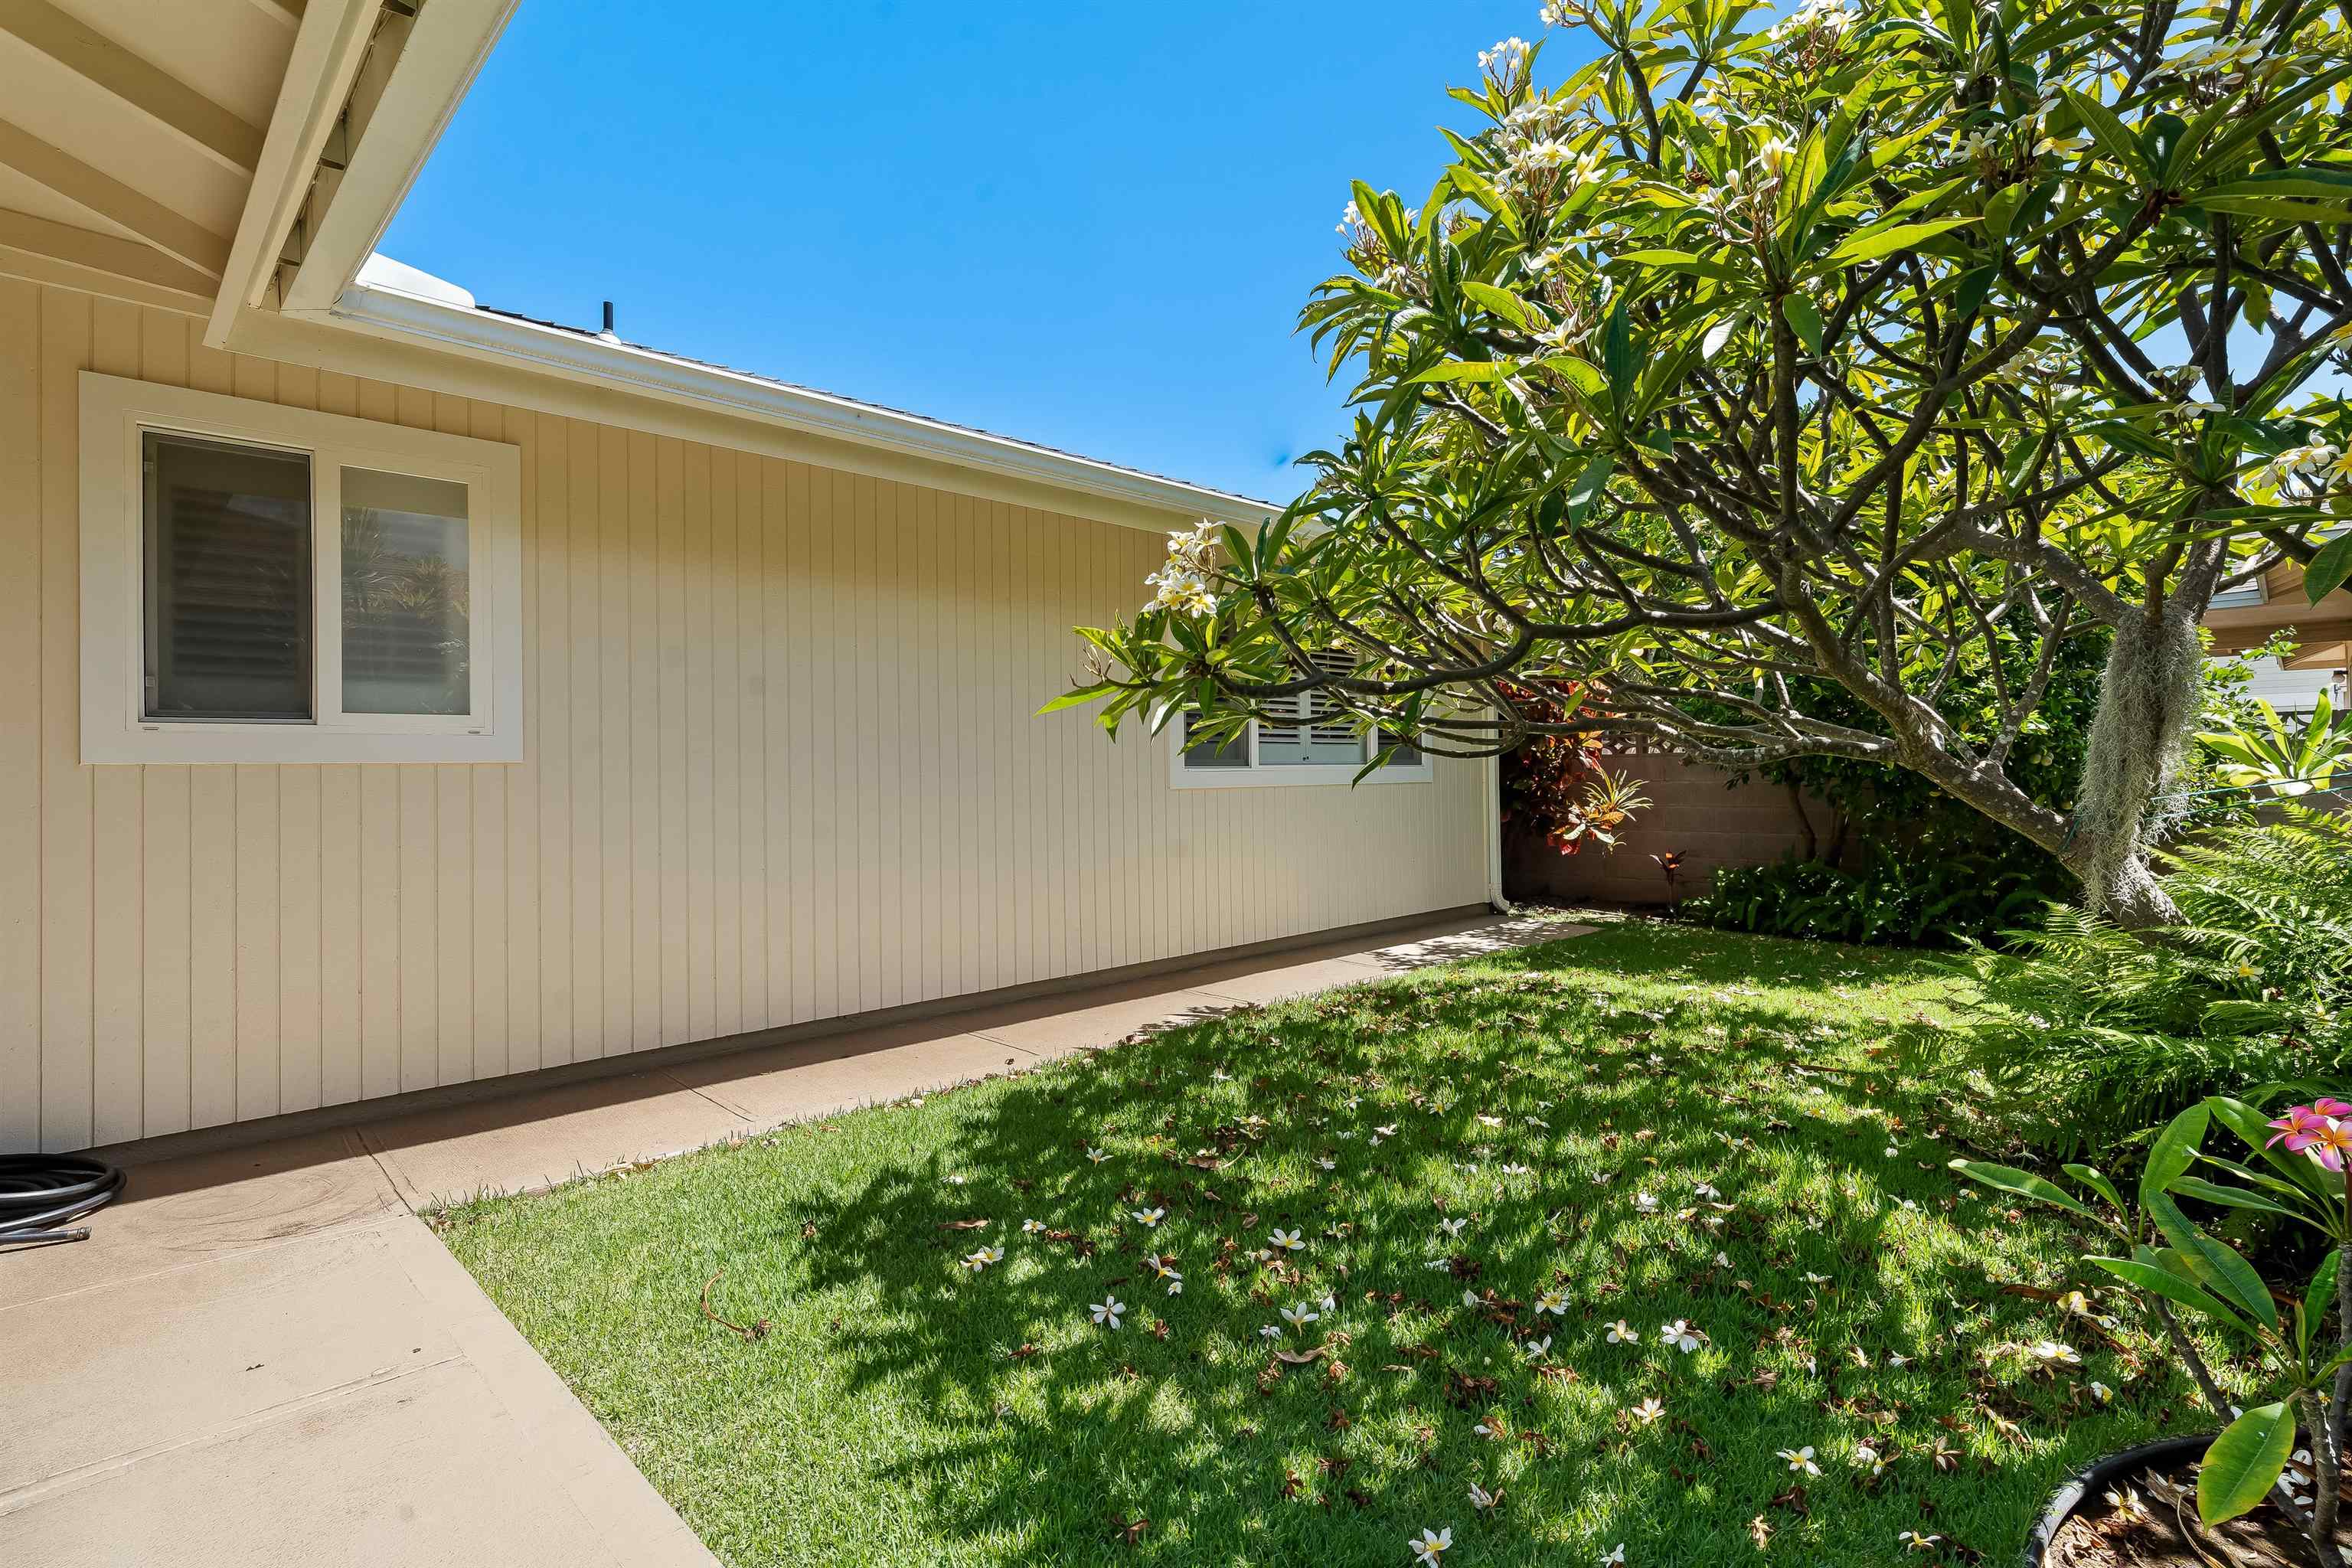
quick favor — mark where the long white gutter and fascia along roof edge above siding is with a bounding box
[284,279,1279,527]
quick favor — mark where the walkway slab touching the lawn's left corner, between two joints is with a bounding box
[360,1072,746,1208]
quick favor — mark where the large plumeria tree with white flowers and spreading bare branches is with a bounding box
[1060,0,2352,924]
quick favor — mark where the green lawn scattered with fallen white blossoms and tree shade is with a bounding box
[443,924,2201,1568]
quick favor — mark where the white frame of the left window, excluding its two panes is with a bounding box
[83,371,522,764]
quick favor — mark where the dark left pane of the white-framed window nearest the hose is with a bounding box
[141,433,311,720]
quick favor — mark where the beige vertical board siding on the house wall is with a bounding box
[0,279,1484,1149]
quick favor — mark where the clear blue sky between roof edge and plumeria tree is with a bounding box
[381,0,1566,501]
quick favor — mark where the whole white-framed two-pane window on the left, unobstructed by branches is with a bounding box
[83,374,522,762]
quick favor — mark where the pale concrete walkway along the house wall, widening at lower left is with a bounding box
[0,920,1588,1568]
